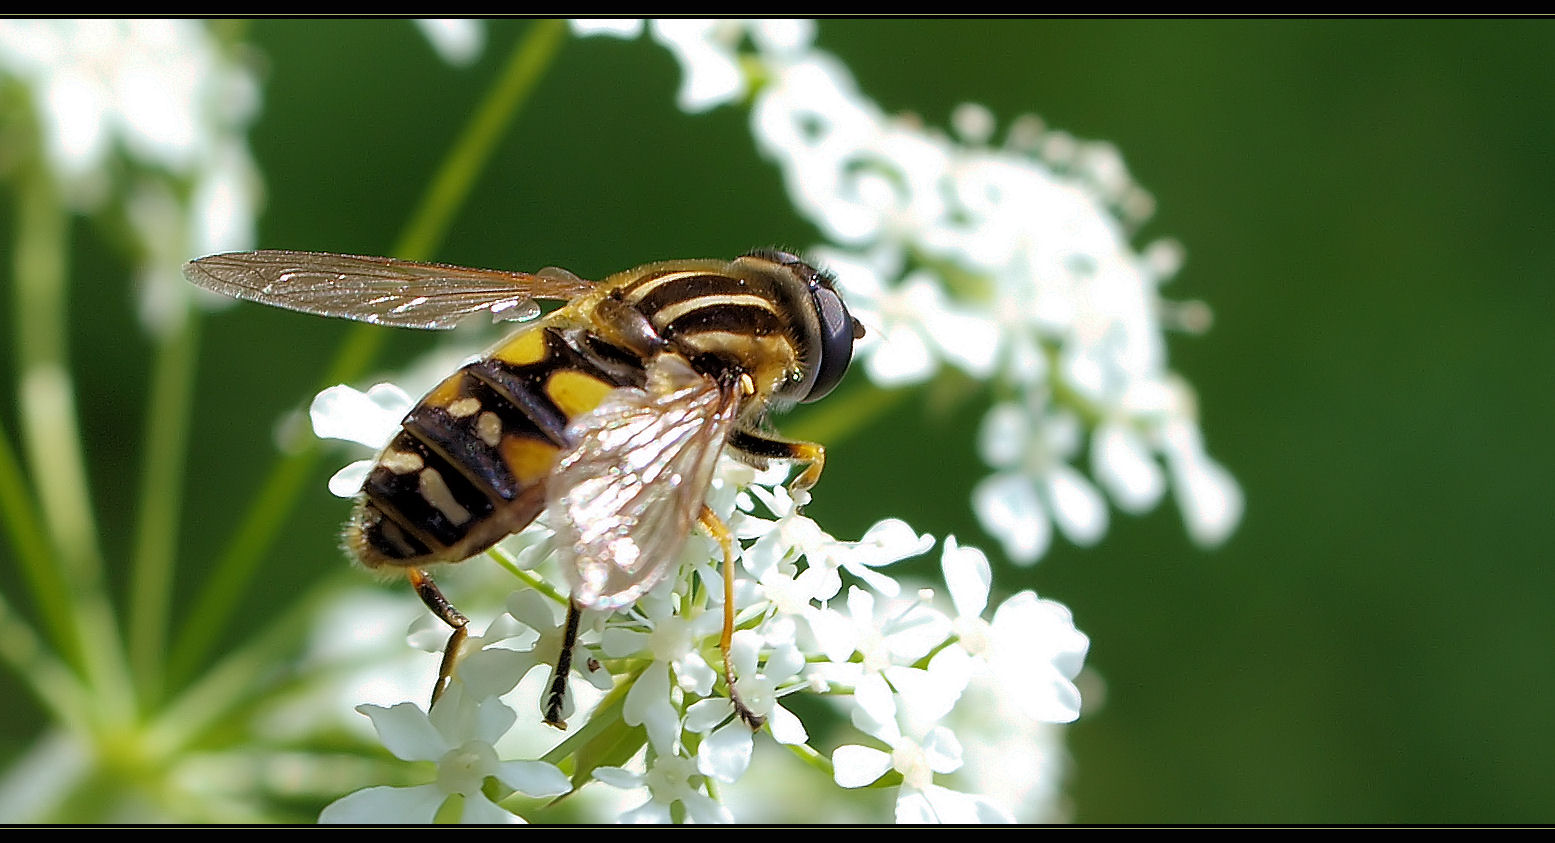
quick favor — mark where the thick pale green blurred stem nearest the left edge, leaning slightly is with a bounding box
[14,168,134,723]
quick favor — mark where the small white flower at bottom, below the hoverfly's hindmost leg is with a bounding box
[319,686,572,824]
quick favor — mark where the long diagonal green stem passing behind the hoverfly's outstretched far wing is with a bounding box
[168,20,566,684]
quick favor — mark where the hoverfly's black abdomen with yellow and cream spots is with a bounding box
[345,324,644,568]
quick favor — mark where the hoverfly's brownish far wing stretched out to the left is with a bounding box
[183,250,594,330]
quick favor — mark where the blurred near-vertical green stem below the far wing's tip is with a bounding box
[129,300,199,709]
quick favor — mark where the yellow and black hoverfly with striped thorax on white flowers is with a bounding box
[183,250,863,728]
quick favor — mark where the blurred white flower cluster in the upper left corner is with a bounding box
[0,19,261,333]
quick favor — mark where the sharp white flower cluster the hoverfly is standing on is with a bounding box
[313,386,1089,823]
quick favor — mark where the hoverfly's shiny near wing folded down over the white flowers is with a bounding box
[547,355,739,608]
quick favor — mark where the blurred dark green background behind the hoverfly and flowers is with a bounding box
[0,20,1555,823]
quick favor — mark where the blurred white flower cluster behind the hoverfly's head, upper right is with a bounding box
[574,20,1242,563]
